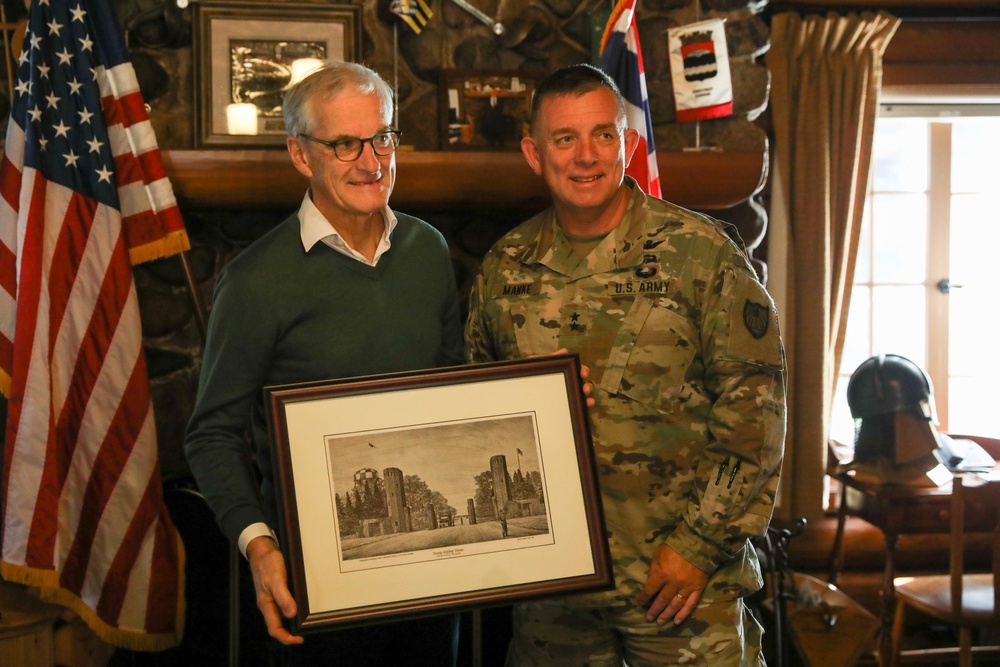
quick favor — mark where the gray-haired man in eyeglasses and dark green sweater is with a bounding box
[185,61,462,665]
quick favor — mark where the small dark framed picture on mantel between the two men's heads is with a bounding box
[438,69,535,151]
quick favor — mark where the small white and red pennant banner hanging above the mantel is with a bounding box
[667,19,733,122]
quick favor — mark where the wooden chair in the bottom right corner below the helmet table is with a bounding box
[891,476,1000,667]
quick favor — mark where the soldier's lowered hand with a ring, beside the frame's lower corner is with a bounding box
[636,544,708,625]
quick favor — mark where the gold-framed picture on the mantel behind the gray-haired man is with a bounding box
[192,1,361,148]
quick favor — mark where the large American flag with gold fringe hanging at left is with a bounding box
[0,0,188,650]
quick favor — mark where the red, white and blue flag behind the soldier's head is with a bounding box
[598,0,663,197]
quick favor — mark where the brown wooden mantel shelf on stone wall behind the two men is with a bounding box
[163,149,767,211]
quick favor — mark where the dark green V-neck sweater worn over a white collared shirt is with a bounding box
[185,213,462,541]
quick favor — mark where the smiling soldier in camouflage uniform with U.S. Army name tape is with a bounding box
[466,65,785,667]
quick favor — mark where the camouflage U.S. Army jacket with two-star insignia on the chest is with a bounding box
[465,179,785,605]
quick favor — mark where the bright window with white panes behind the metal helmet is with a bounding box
[831,105,1000,445]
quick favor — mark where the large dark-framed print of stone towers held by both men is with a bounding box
[264,355,614,632]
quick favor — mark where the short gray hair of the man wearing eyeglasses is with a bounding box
[281,60,393,137]
